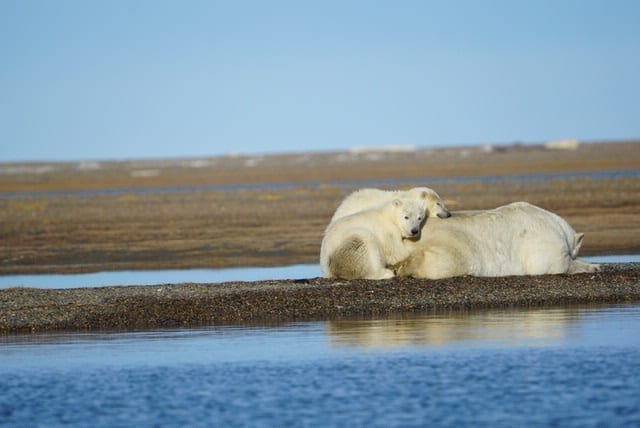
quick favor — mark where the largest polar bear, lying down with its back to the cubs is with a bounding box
[395,202,599,279]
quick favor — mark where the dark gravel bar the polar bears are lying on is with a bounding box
[0,263,640,333]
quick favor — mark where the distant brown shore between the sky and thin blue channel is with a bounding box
[0,140,640,192]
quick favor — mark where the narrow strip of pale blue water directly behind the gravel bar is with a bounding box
[0,254,640,289]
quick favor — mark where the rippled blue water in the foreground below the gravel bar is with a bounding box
[0,305,640,427]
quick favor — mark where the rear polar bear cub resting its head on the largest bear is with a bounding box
[331,187,451,222]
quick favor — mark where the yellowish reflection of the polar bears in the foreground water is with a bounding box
[325,308,580,349]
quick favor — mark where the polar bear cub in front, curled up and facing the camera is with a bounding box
[320,198,426,279]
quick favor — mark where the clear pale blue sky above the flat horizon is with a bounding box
[0,0,640,161]
